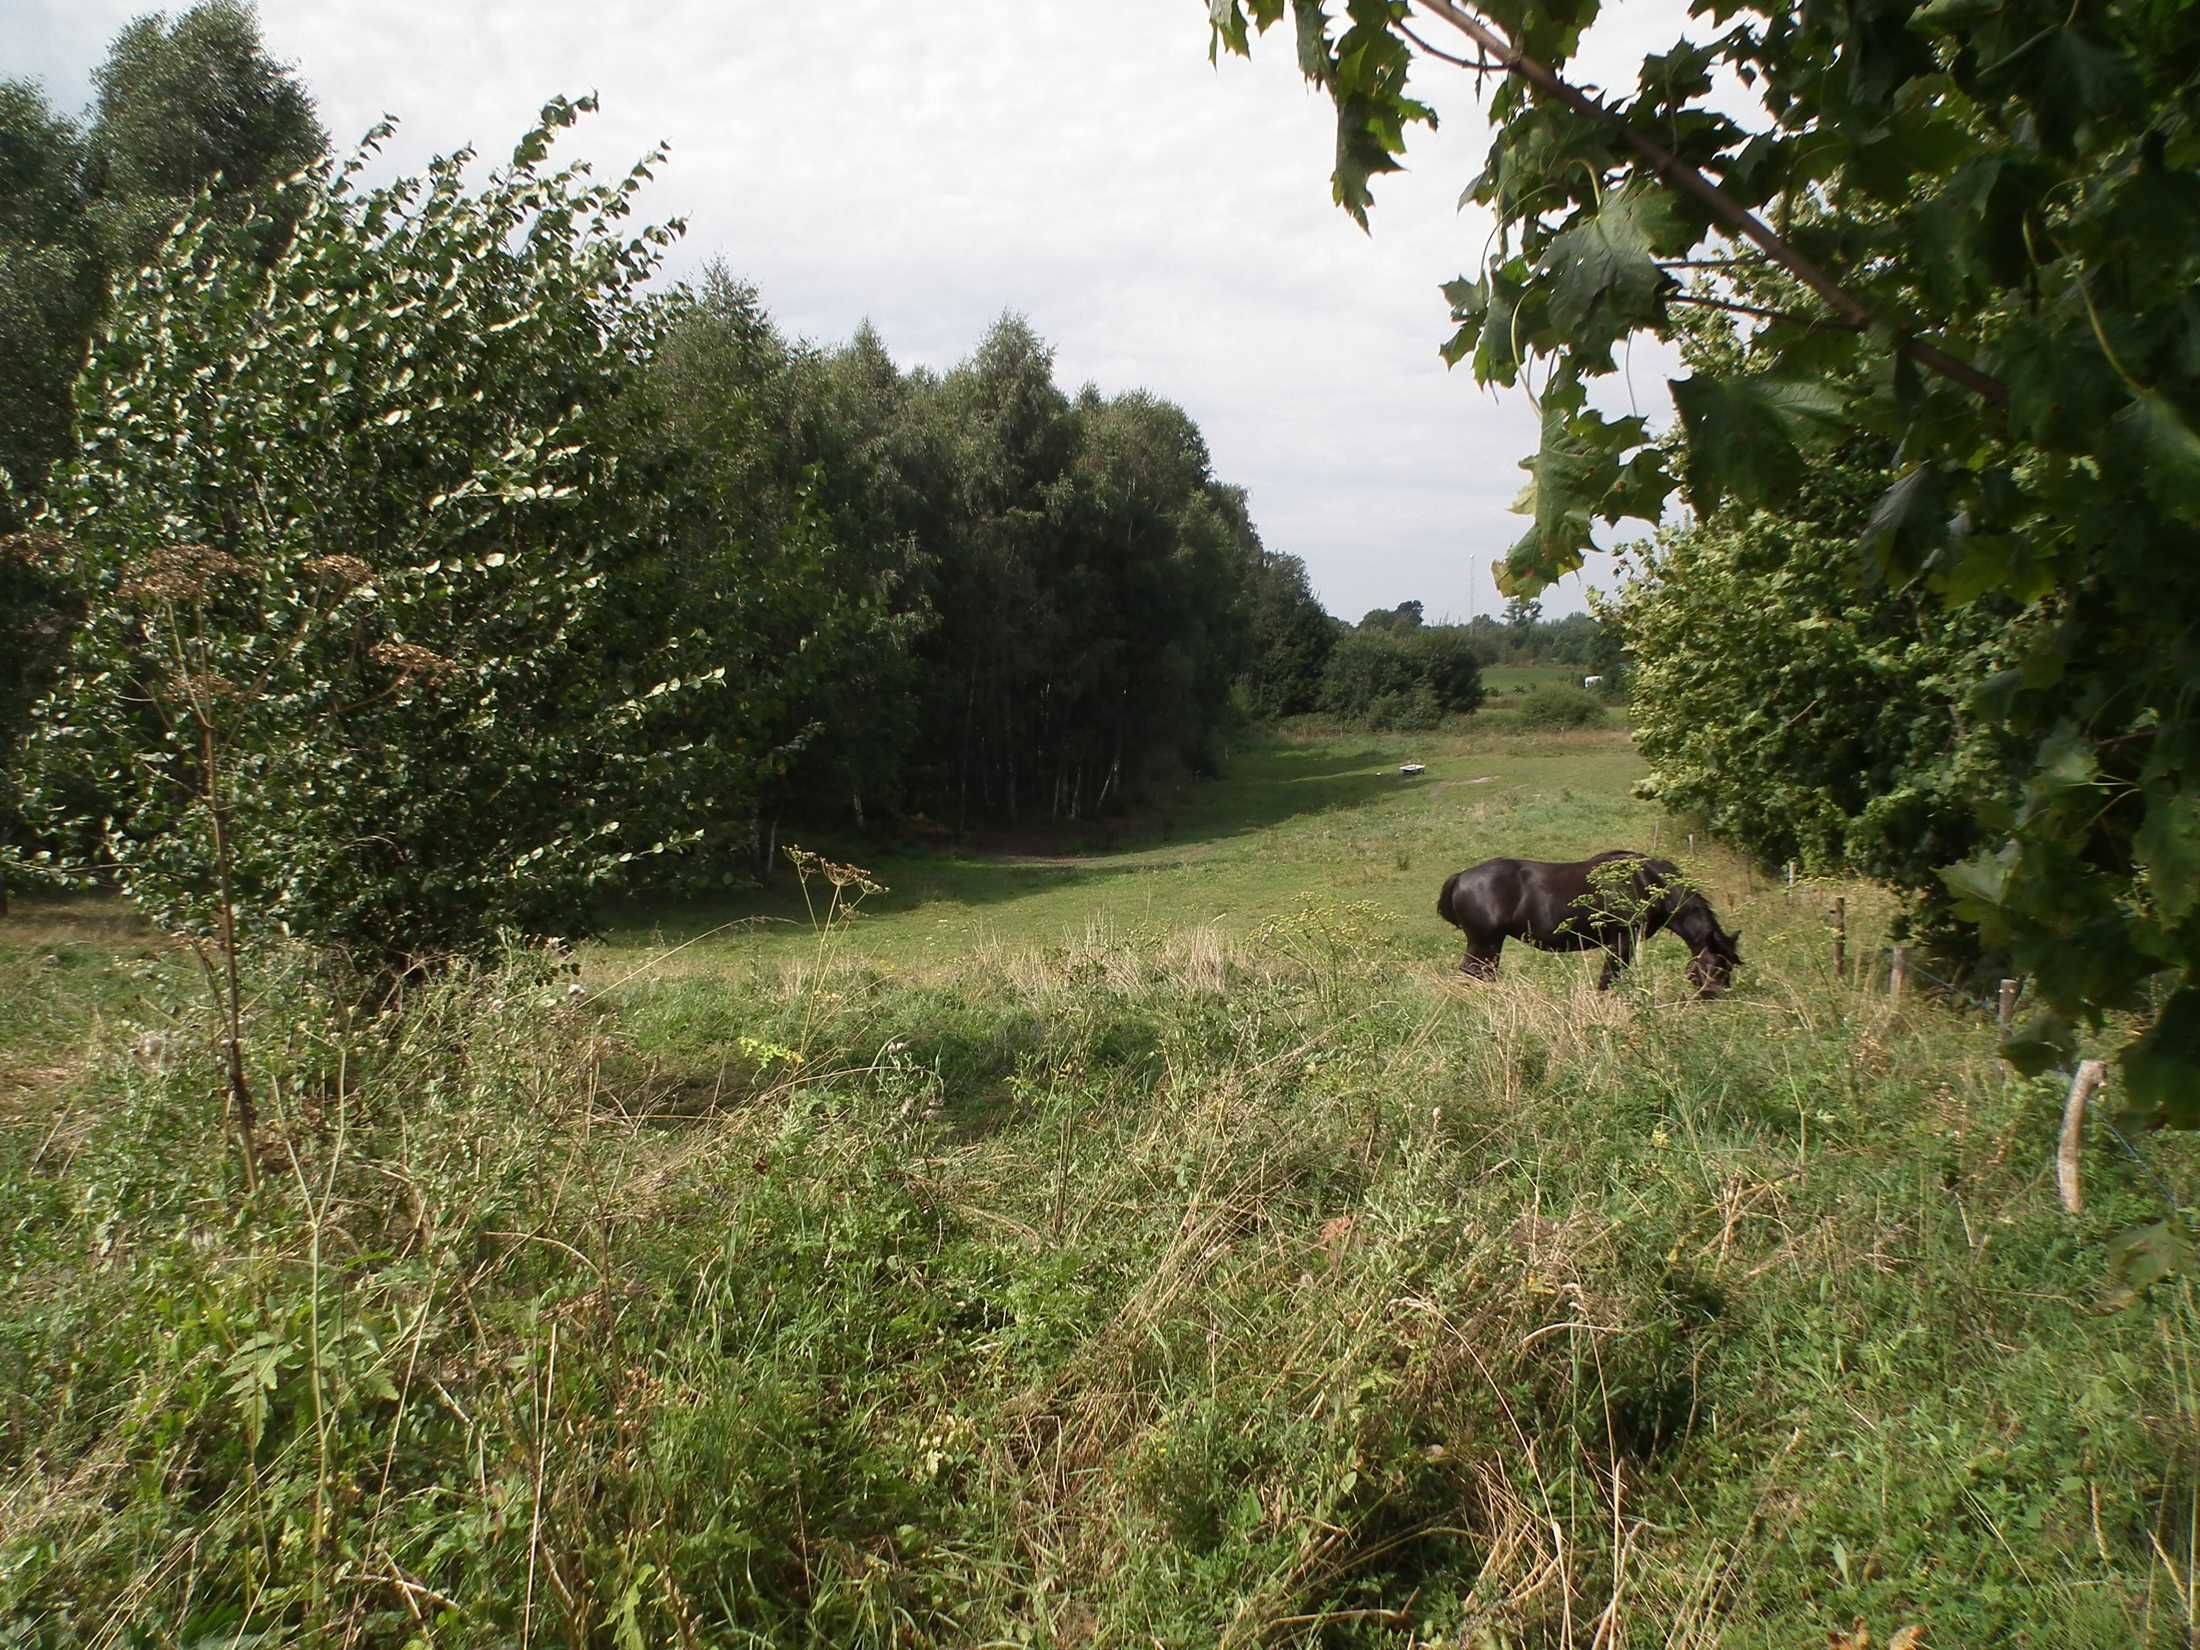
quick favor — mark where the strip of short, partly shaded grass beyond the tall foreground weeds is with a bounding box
[594,724,1663,970]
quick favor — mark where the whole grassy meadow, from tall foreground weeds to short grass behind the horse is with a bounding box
[0,717,2200,1650]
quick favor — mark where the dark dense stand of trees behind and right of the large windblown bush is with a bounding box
[651,279,1278,843]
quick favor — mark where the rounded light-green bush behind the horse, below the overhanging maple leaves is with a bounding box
[1599,426,2022,944]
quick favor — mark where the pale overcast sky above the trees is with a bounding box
[0,0,1683,618]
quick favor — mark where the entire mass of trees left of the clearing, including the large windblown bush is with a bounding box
[0,0,1335,961]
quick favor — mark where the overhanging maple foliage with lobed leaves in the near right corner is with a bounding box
[1210,0,2200,1122]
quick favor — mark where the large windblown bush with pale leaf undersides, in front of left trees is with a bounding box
[33,101,721,961]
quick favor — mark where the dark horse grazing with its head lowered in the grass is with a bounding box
[1437,847,1742,997]
